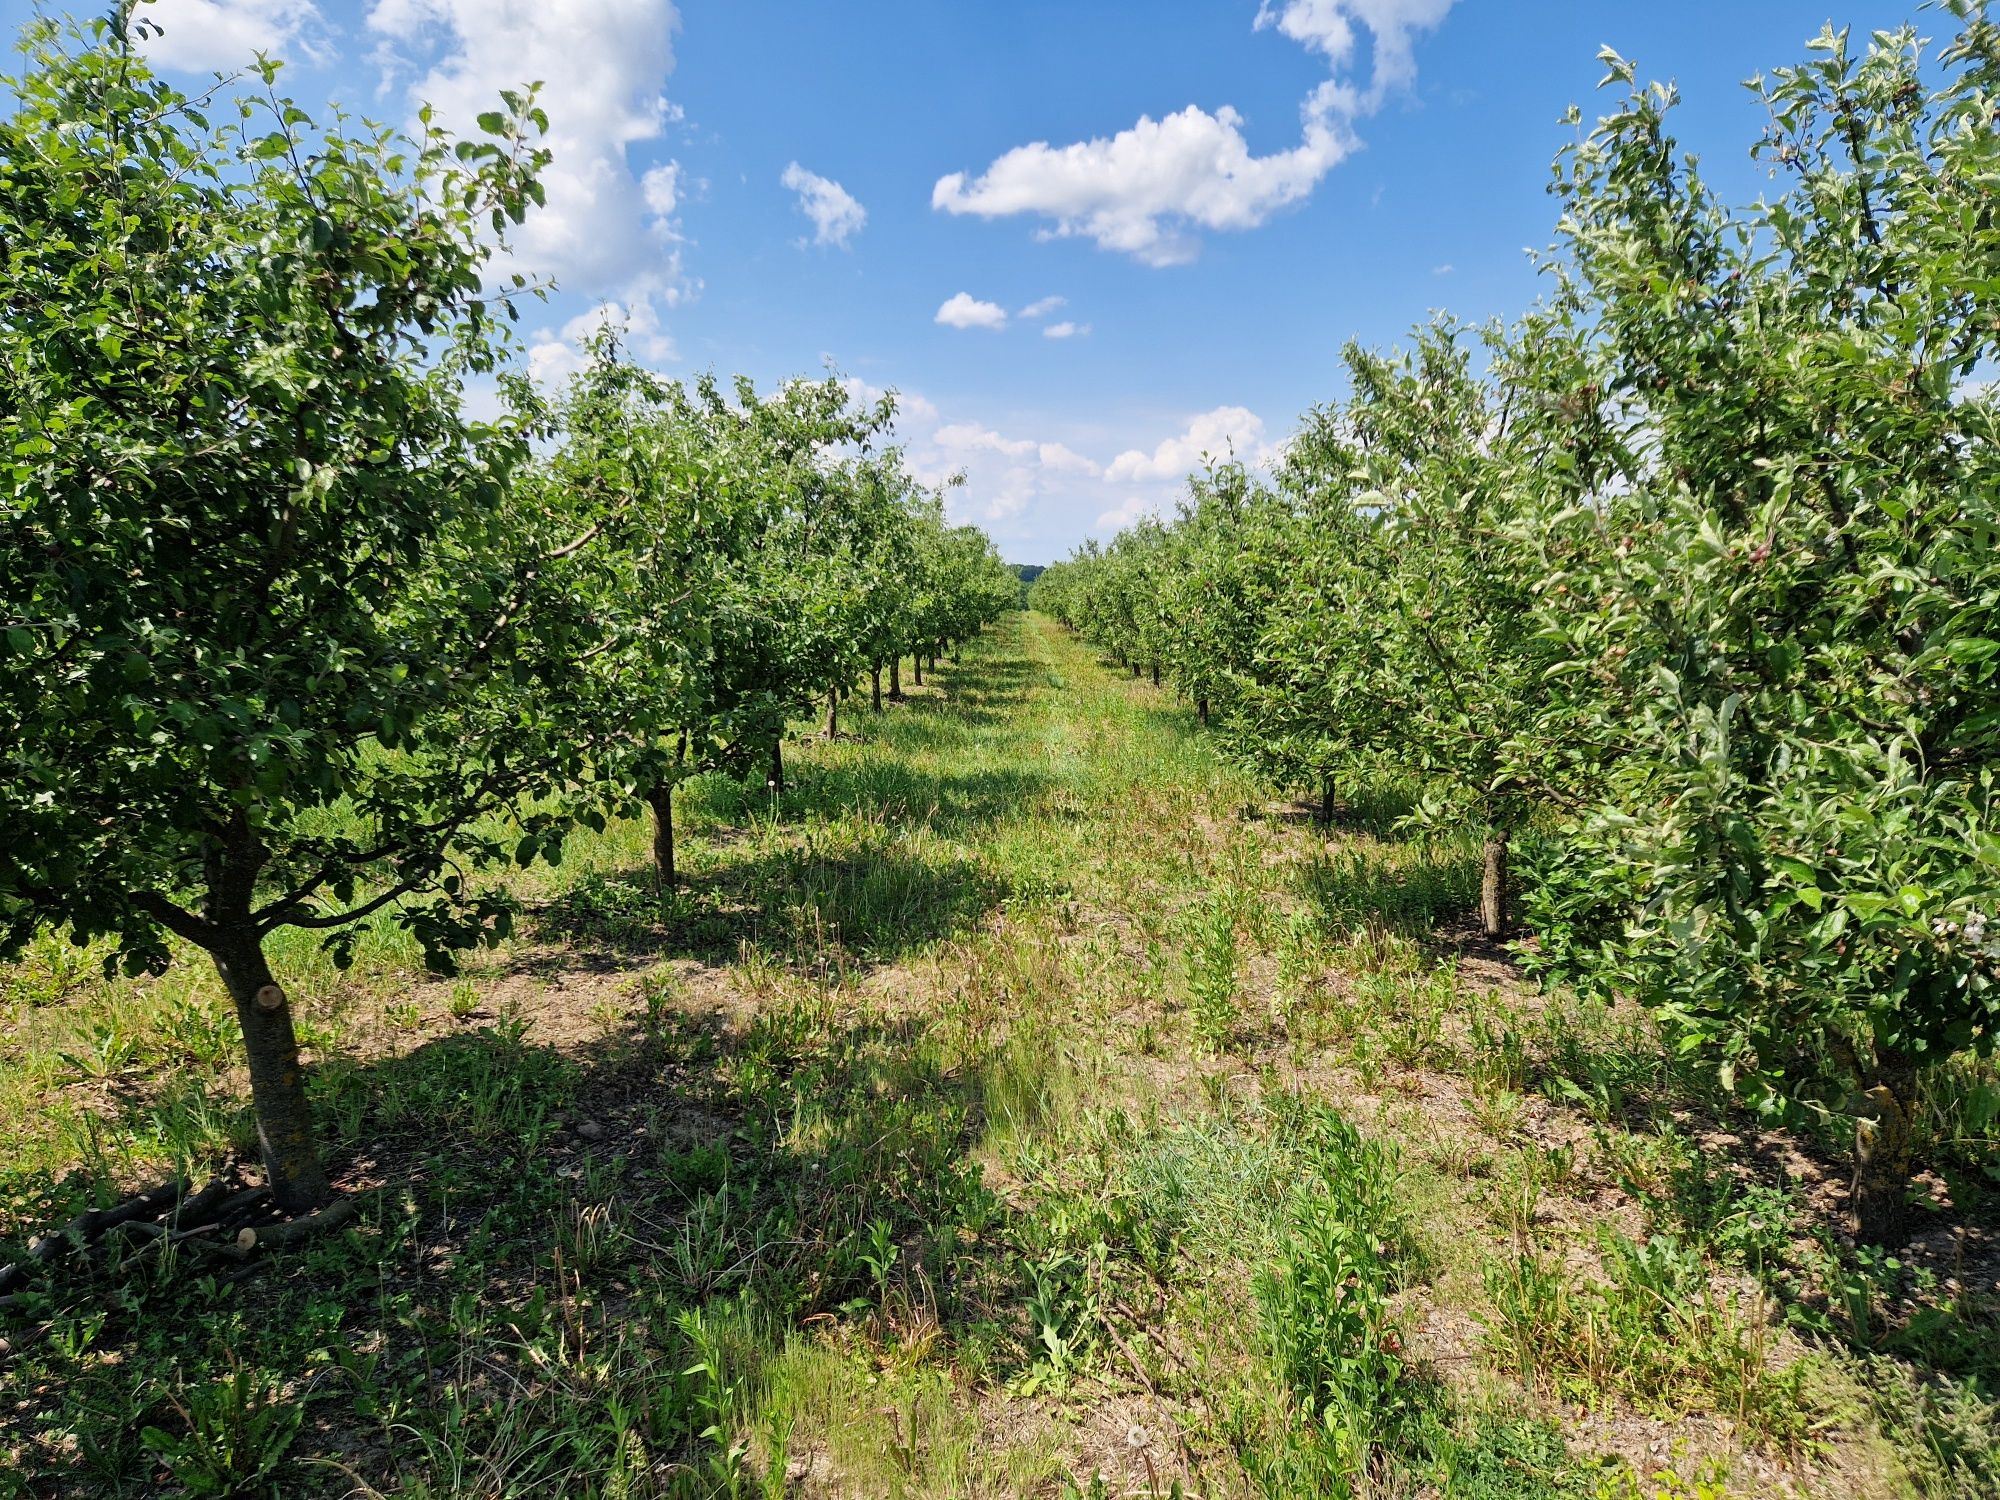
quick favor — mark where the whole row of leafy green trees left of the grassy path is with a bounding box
[0,8,1018,1208]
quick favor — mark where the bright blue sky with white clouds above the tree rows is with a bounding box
[0,0,1946,562]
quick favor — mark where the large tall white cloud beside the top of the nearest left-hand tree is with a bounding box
[368,0,694,306]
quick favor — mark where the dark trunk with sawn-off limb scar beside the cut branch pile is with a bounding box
[208,932,334,1214]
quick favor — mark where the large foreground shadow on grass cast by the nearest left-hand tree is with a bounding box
[10,956,1064,1496]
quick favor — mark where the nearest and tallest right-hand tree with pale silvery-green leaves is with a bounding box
[1540,20,2000,1242]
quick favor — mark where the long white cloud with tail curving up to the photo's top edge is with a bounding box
[930,0,1452,266]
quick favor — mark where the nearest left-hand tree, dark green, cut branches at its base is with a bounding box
[0,20,588,1210]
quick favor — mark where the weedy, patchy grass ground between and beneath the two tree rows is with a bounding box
[0,616,2000,1500]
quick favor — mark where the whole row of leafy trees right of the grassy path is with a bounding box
[1032,0,2000,1238]
